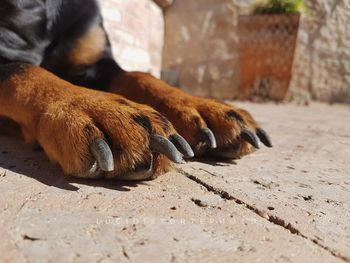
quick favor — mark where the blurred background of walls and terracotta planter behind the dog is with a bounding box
[100,0,350,104]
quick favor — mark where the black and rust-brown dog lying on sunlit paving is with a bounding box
[0,0,272,180]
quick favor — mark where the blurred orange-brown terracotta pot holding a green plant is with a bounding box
[238,14,300,101]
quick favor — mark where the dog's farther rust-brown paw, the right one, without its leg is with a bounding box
[162,96,272,159]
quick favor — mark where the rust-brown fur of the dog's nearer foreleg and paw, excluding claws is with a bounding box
[0,66,175,177]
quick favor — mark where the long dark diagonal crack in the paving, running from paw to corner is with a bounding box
[177,168,350,263]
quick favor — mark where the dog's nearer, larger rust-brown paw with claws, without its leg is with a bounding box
[36,93,193,180]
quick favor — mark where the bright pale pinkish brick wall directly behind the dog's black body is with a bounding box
[99,0,164,76]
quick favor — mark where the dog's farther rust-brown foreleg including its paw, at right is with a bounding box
[109,72,272,159]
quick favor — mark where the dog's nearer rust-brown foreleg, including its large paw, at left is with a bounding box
[0,63,191,180]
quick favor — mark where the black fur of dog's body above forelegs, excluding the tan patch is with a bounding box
[0,0,122,90]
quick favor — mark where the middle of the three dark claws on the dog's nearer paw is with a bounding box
[150,134,184,163]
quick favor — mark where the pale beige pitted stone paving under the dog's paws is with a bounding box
[0,104,350,262]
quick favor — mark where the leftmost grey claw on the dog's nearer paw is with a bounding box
[90,139,114,172]
